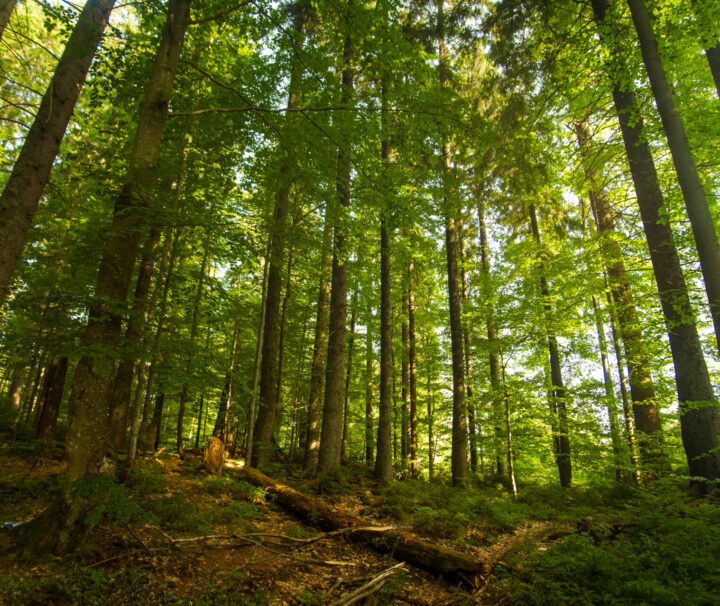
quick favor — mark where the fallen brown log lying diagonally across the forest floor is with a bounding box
[238,467,488,588]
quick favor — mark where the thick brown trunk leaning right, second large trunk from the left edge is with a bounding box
[63,0,190,496]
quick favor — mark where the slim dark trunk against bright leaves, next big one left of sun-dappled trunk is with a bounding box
[528,204,572,488]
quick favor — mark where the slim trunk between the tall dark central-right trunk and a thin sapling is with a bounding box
[477,199,507,476]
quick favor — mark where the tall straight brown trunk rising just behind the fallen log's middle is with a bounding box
[318,26,355,475]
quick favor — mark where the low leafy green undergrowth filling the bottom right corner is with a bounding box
[492,487,720,606]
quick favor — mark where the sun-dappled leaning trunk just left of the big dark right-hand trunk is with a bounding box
[575,121,665,472]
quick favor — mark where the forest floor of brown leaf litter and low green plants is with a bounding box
[0,442,720,605]
